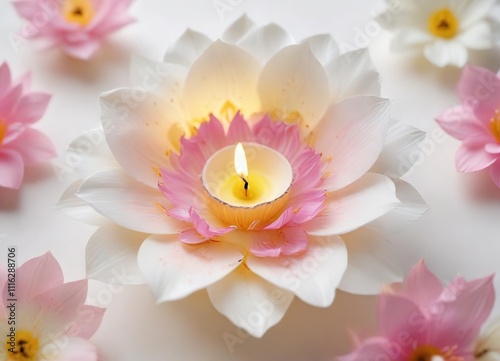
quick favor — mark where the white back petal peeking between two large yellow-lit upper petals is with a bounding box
[237,24,294,63]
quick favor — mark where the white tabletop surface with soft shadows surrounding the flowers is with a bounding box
[0,0,500,361]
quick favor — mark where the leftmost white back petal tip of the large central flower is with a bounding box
[57,180,108,226]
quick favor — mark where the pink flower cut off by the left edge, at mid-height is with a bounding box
[0,63,55,189]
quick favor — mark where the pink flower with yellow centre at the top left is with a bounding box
[12,0,134,60]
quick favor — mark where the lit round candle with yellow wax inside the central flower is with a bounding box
[201,143,293,229]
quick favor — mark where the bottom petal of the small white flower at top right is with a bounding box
[424,40,469,68]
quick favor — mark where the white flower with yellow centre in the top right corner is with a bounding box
[377,0,497,67]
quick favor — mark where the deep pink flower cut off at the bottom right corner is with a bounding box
[339,262,495,361]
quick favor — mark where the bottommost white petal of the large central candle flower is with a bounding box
[208,265,293,337]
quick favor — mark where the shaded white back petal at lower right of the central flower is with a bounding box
[338,227,403,295]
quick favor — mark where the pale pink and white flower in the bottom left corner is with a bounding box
[0,252,104,361]
